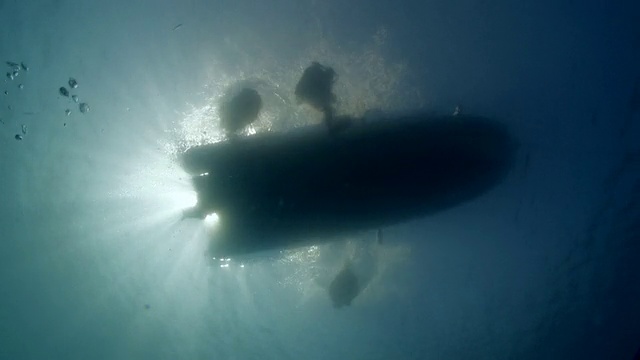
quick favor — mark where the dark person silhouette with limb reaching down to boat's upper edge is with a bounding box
[295,61,351,132]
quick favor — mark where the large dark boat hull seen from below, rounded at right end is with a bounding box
[182,116,516,256]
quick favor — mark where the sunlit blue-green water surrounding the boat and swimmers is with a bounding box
[0,0,640,359]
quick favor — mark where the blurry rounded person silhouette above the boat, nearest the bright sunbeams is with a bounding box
[220,88,262,134]
